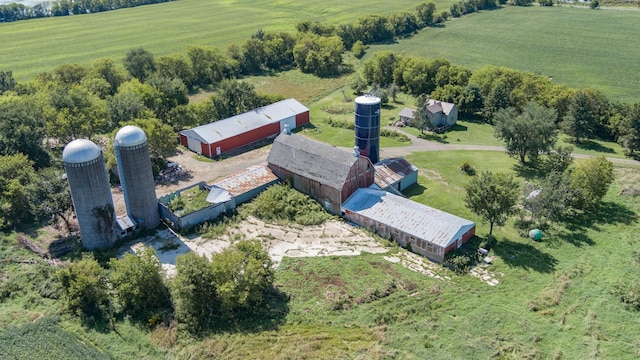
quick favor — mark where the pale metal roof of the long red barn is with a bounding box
[180,99,309,144]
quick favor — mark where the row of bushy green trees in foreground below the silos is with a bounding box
[56,240,286,333]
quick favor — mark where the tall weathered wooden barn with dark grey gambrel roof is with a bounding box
[267,133,374,214]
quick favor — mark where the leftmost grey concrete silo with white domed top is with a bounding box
[62,139,117,250]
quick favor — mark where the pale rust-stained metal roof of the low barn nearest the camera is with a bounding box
[342,188,475,248]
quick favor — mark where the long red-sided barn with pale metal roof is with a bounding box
[180,99,309,157]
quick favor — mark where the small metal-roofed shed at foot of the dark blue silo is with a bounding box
[374,158,418,191]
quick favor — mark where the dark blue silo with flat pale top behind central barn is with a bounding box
[355,95,380,164]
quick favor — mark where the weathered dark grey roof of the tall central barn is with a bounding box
[267,134,359,190]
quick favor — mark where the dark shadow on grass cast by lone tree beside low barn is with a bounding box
[493,238,558,273]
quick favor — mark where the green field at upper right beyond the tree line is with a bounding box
[369,6,640,102]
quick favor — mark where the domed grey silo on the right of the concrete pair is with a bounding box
[113,125,160,229]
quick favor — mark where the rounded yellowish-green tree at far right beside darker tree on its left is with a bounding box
[571,156,614,210]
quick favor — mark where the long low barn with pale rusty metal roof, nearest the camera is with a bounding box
[342,188,476,262]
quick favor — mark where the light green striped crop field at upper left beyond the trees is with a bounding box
[0,0,453,81]
